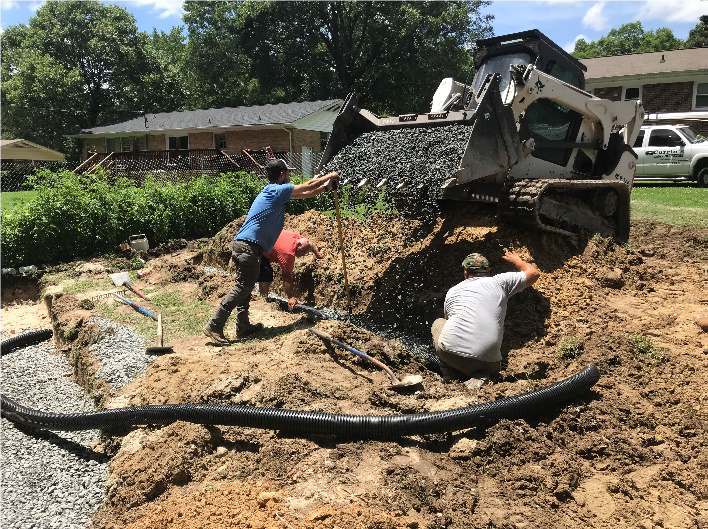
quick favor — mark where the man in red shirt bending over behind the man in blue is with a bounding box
[258,230,324,310]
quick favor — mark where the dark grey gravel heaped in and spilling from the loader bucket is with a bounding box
[322,125,472,216]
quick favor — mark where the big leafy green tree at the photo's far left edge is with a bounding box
[0,0,181,150]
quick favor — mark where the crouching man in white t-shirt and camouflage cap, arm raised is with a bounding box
[431,250,540,376]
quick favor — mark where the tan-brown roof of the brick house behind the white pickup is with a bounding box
[580,48,708,81]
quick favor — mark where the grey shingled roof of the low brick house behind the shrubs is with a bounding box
[77,99,342,135]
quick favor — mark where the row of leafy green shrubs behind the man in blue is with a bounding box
[0,170,390,267]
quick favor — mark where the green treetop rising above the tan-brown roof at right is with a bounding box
[573,22,684,59]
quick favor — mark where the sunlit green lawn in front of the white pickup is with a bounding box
[631,184,708,227]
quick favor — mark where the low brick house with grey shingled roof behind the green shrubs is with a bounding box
[71,99,342,173]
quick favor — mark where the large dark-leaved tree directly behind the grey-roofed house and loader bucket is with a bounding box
[184,0,491,111]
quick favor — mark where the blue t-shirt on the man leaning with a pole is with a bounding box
[236,184,294,253]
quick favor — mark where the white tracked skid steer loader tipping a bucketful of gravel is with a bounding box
[319,30,644,241]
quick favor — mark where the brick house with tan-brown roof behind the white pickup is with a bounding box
[580,48,708,135]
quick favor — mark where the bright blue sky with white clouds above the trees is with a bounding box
[0,0,708,50]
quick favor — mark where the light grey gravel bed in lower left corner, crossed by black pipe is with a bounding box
[0,330,108,529]
